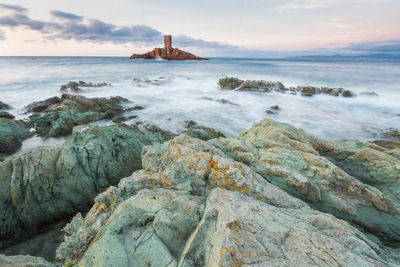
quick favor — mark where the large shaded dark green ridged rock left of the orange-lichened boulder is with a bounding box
[0,126,168,247]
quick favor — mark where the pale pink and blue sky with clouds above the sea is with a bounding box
[0,0,400,57]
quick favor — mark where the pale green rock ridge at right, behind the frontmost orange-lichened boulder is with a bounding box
[210,119,400,240]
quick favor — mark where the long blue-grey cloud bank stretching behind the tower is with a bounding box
[0,4,237,49]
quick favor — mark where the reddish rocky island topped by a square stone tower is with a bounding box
[131,35,207,60]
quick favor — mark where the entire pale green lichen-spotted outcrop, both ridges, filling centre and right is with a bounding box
[57,120,400,266]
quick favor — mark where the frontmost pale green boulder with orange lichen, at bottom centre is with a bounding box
[57,135,400,266]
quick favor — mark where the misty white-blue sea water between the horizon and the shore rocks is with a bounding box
[0,57,400,143]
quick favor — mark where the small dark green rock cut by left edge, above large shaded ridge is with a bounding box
[0,118,33,154]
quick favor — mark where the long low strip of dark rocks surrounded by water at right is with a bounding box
[218,78,355,97]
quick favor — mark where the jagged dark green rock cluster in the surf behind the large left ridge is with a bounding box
[26,94,128,137]
